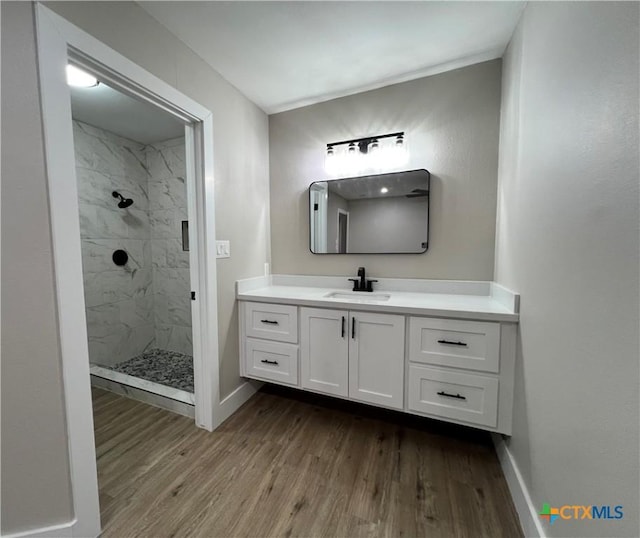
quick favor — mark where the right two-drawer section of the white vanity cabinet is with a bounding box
[407,317,515,433]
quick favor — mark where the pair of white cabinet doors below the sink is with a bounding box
[300,308,404,409]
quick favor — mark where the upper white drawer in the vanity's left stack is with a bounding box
[245,303,298,344]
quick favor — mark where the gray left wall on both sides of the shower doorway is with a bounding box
[2,2,269,533]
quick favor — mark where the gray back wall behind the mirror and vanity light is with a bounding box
[269,60,501,280]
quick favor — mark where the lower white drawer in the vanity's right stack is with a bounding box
[408,364,498,427]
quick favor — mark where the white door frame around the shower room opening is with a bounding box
[36,4,220,537]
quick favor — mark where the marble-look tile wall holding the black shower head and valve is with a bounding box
[74,121,155,365]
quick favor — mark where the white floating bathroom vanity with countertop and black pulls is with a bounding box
[236,275,519,434]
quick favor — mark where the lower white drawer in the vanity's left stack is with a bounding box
[245,338,298,385]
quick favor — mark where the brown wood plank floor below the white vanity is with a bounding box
[93,388,522,538]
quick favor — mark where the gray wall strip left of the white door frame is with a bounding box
[0,2,73,534]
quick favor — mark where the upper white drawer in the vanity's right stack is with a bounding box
[409,317,500,373]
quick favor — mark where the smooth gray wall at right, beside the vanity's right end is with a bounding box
[496,2,640,537]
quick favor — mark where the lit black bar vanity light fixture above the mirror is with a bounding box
[325,132,408,176]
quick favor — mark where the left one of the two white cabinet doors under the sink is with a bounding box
[300,308,350,396]
